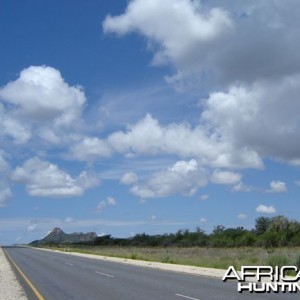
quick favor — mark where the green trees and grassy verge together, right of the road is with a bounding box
[34,216,300,269]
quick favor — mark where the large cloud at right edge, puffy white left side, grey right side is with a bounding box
[202,75,300,163]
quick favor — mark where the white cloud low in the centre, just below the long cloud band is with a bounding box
[130,159,207,199]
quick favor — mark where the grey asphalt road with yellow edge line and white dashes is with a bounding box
[4,247,299,300]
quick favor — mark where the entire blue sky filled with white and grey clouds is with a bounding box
[0,0,300,245]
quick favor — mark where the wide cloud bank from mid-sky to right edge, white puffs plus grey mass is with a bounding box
[99,75,300,168]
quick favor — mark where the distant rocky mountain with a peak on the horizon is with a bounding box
[30,227,97,245]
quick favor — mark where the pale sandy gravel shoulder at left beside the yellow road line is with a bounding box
[0,247,27,300]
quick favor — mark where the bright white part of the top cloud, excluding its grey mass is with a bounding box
[103,0,232,70]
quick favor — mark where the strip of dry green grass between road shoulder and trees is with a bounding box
[40,246,300,269]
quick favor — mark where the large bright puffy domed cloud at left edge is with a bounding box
[0,66,85,125]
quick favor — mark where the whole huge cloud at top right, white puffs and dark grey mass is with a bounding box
[103,0,300,87]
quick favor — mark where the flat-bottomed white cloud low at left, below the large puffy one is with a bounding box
[11,157,99,197]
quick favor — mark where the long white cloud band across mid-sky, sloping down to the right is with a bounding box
[107,114,262,168]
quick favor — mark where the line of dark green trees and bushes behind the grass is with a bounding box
[41,216,300,248]
